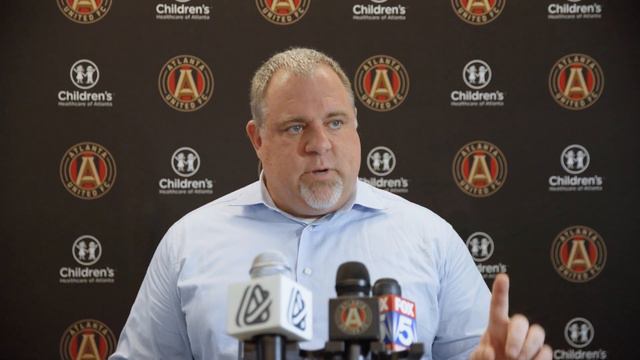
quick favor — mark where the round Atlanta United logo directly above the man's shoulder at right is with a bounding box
[453,140,507,197]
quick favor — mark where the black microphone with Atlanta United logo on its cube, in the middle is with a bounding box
[326,261,380,359]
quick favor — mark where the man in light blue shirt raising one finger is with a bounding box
[111,49,551,360]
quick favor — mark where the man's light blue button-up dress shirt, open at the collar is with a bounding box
[110,181,490,360]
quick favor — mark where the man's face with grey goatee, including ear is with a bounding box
[247,65,360,217]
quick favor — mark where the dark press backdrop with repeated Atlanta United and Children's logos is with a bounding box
[0,0,640,359]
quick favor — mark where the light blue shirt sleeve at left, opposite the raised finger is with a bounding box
[109,226,193,360]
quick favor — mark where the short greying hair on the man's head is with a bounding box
[249,48,355,127]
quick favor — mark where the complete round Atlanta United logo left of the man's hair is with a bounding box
[158,55,213,112]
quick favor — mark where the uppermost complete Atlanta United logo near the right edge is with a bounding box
[549,54,604,110]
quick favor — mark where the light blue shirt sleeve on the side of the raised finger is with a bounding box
[432,229,491,360]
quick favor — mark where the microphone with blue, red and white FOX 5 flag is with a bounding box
[373,278,417,352]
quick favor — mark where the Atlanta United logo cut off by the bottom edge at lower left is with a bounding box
[60,319,116,360]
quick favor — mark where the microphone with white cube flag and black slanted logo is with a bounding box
[227,251,313,360]
